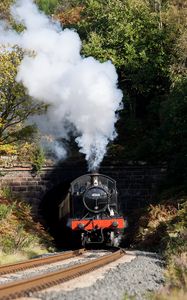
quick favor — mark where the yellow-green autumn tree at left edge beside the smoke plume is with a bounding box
[0,48,45,145]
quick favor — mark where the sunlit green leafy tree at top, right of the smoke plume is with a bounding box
[78,0,172,92]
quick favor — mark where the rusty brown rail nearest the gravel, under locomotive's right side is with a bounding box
[0,249,124,300]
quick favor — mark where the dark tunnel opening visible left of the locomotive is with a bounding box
[39,180,71,249]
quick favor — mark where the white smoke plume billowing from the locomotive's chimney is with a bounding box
[0,0,122,170]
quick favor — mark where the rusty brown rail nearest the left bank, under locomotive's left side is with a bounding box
[0,248,85,275]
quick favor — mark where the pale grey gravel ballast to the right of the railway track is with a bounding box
[30,251,164,300]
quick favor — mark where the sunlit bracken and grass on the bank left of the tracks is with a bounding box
[0,193,52,264]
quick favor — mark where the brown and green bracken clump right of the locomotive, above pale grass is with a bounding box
[131,196,187,252]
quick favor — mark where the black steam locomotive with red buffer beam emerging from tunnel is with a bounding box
[59,173,125,246]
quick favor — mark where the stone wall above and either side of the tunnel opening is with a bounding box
[0,163,166,216]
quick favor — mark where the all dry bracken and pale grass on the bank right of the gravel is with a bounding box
[128,193,187,300]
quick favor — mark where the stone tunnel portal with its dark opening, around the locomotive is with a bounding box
[0,161,166,245]
